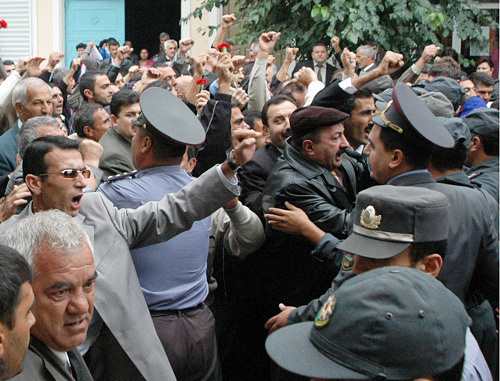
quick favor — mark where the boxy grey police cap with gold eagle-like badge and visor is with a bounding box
[337,185,449,259]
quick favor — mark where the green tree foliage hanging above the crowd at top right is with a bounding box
[183,0,496,61]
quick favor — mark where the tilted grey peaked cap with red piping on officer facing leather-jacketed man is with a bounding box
[372,83,455,148]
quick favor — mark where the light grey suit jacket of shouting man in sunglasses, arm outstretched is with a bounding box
[0,168,235,381]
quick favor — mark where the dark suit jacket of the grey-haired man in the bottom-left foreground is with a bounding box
[12,336,93,381]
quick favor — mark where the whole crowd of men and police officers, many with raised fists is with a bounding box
[0,15,499,381]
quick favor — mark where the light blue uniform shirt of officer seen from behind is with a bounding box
[99,165,211,310]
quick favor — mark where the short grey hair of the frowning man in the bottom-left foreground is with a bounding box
[0,209,94,275]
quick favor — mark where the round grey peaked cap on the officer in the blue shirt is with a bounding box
[132,87,205,145]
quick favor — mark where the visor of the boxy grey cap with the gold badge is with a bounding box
[337,233,411,259]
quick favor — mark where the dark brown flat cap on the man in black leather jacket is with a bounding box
[290,106,349,137]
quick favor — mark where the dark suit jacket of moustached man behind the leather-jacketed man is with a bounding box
[238,143,281,217]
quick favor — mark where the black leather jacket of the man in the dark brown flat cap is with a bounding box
[237,142,369,305]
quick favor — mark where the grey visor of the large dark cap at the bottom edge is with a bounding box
[266,322,370,380]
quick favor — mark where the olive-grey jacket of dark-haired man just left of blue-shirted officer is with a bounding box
[99,127,135,177]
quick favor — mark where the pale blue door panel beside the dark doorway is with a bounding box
[65,0,125,66]
